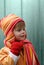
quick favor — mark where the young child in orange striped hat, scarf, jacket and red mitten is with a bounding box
[0,14,40,65]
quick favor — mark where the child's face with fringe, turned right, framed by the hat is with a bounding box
[14,22,26,41]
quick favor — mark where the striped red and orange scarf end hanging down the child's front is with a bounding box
[24,40,40,65]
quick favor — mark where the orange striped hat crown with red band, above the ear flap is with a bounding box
[0,14,23,36]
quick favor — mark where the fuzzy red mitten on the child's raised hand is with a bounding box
[11,41,24,56]
